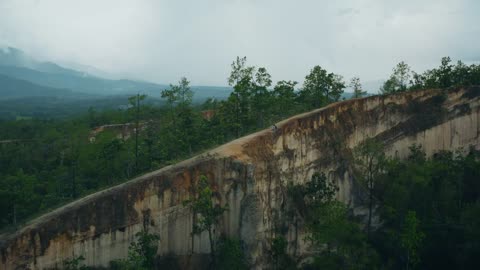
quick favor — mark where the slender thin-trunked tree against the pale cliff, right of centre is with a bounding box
[354,138,386,238]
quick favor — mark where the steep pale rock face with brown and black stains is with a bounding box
[0,87,480,269]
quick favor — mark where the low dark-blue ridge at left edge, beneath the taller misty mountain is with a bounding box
[0,74,81,100]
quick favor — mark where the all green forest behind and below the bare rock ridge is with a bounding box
[0,57,480,269]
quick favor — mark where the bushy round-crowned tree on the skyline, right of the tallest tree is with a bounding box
[300,66,345,109]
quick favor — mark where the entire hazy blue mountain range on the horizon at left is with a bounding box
[0,47,231,118]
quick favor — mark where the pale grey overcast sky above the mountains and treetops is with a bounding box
[0,0,480,85]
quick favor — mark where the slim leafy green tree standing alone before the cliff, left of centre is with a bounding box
[183,175,227,265]
